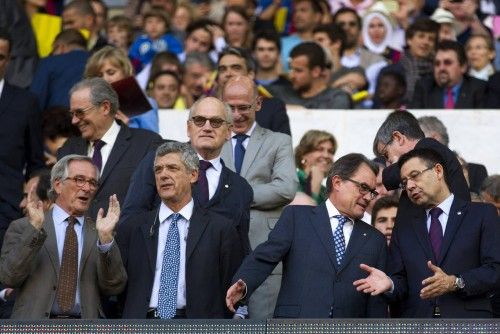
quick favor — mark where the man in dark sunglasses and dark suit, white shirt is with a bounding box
[121,97,253,254]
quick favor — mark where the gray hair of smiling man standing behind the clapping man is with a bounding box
[69,78,120,115]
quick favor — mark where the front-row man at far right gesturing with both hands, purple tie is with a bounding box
[354,149,500,318]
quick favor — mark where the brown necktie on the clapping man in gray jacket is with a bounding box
[56,216,78,313]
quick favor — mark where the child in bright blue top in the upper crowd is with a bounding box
[129,9,182,73]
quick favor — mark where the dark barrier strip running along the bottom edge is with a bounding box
[0,319,500,334]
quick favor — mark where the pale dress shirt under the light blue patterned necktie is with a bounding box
[149,199,194,309]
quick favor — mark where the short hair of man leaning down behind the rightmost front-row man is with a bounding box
[373,110,425,156]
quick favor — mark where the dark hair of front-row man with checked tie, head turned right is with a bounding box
[326,153,378,194]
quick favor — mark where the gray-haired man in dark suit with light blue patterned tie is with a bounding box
[117,142,243,319]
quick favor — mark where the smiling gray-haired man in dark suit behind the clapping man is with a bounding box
[57,78,162,219]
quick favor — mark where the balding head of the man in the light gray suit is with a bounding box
[222,76,261,134]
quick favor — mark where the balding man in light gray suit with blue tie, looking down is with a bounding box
[221,76,297,319]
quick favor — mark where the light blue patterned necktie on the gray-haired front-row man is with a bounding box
[158,213,182,319]
